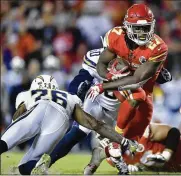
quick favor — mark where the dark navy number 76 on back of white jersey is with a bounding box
[31,89,67,108]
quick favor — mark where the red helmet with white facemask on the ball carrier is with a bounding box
[123,4,155,45]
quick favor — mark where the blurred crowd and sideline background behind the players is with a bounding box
[0,0,181,174]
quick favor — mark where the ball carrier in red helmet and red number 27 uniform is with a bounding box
[87,4,168,138]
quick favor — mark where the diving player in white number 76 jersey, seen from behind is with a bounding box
[0,75,133,175]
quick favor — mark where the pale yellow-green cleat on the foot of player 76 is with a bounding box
[31,153,51,175]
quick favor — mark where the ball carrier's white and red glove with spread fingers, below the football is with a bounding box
[86,84,104,102]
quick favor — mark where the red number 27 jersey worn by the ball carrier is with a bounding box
[105,27,168,94]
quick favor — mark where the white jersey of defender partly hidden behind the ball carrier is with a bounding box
[82,48,120,111]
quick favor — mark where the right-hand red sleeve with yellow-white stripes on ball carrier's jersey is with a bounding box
[148,40,168,62]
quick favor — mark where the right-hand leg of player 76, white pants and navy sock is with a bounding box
[19,105,69,175]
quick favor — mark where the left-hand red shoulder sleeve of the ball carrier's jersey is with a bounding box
[105,27,123,52]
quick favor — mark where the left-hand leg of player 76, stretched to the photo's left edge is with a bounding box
[0,105,46,153]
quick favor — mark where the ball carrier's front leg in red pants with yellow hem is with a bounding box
[116,88,146,133]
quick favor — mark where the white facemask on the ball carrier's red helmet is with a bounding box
[124,20,155,46]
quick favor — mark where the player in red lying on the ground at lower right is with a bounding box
[105,123,181,173]
